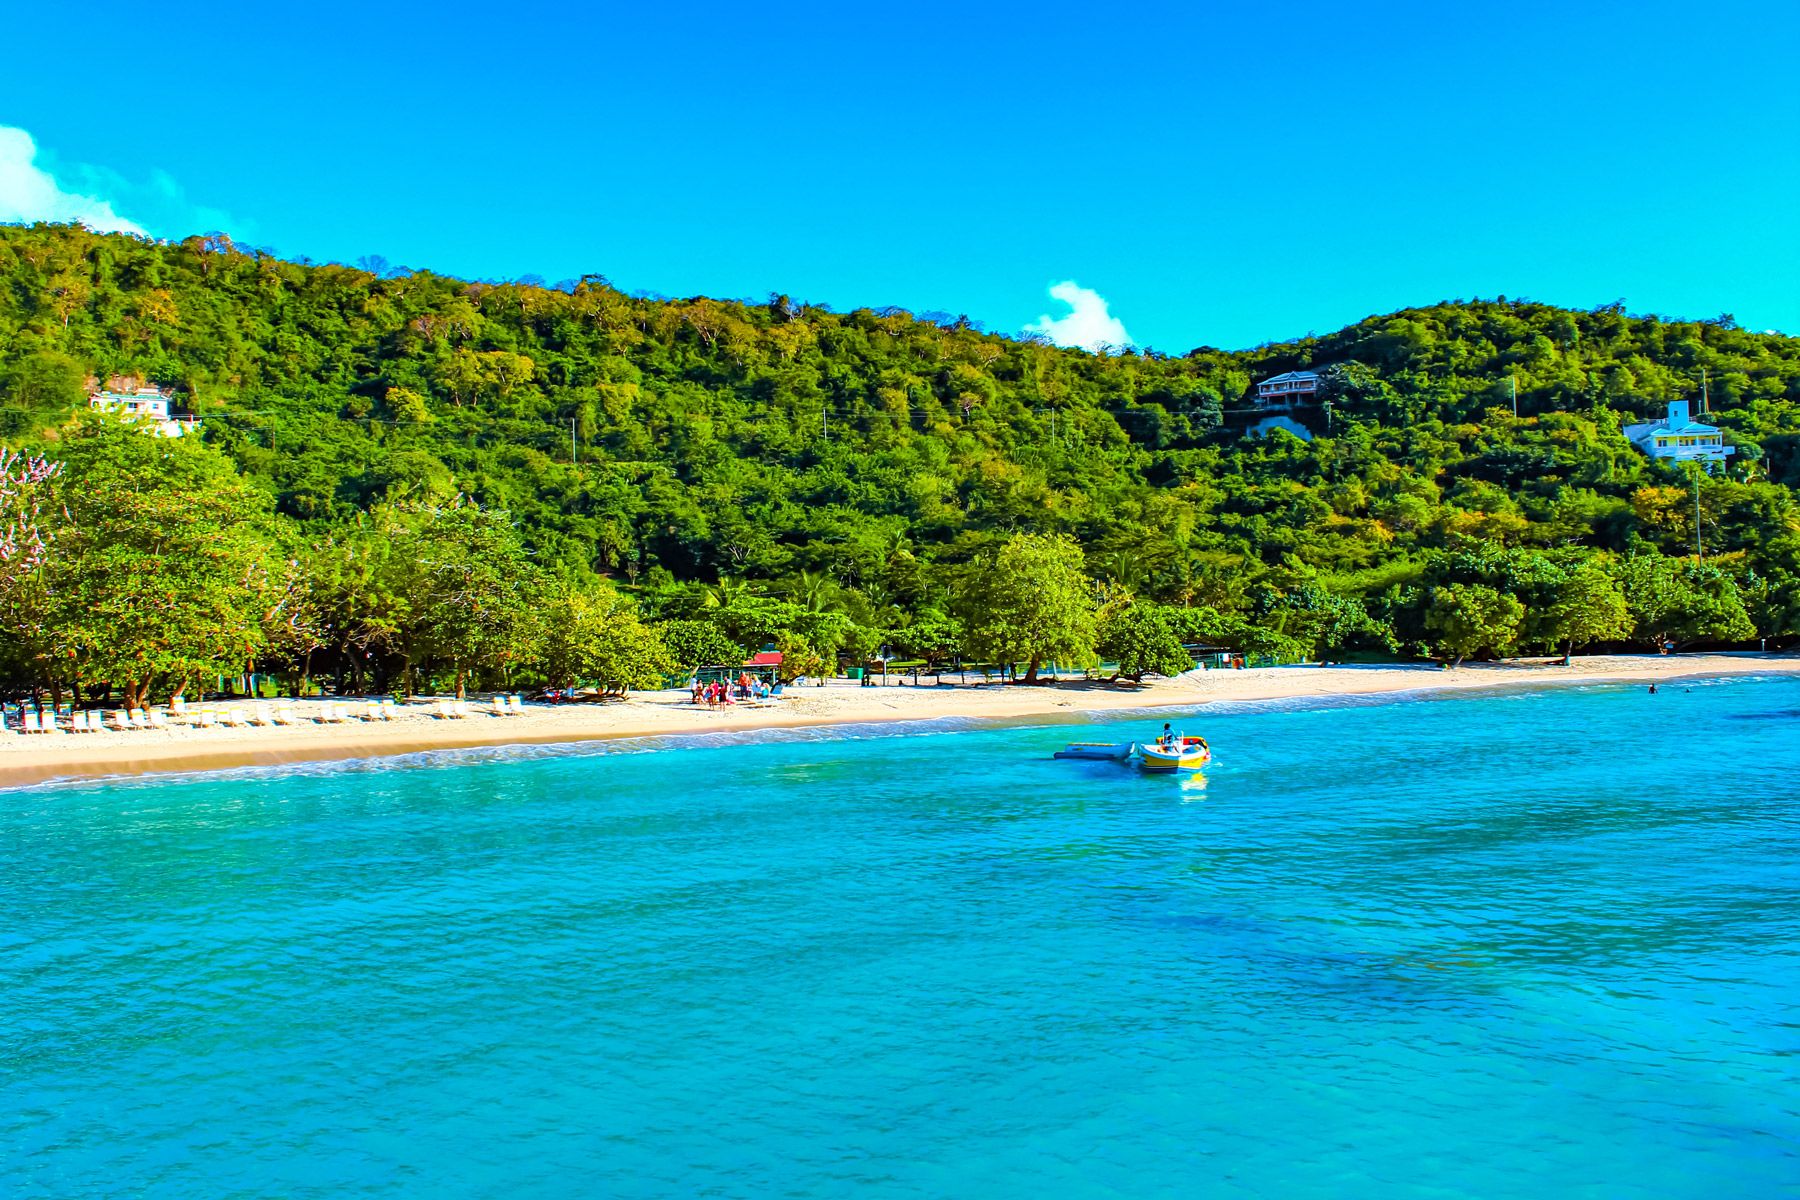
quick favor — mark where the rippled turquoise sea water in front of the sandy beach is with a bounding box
[0,680,1800,1200]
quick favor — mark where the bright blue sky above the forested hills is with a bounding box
[0,0,1800,353]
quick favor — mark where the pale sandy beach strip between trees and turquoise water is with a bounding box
[0,653,1800,790]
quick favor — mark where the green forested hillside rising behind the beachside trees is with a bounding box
[0,227,1800,662]
